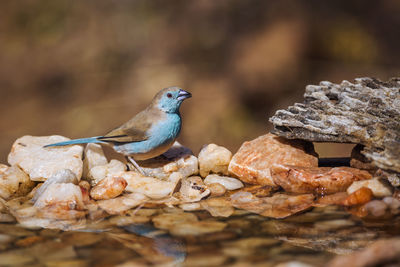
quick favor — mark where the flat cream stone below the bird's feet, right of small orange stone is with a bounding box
[119,171,183,199]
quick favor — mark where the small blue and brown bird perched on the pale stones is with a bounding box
[44,86,192,175]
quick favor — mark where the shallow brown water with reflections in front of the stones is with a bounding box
[0,206,400,267]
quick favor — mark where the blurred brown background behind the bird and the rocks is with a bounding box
[0,0,400,162]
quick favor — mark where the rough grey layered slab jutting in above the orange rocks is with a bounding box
[270,78,400,176]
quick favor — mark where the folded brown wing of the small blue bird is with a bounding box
[98,109,162,143]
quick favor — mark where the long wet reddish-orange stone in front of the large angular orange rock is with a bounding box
[271,164,372,194]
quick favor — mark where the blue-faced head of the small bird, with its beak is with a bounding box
[152,87,192,113]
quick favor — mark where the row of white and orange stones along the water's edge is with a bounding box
[0,127,400,229]
